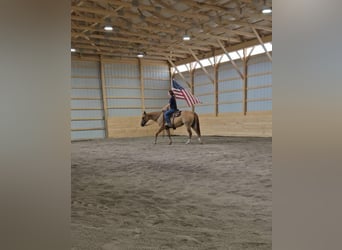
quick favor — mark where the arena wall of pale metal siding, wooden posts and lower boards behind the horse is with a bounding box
[71,51,272,140]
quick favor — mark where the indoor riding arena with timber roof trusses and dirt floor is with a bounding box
[70,0,272,250]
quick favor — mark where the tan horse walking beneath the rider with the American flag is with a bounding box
[141,110,202,145]
